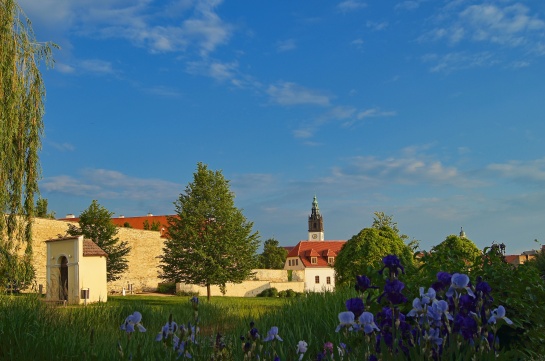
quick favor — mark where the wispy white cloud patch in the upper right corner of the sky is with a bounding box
[418,1,545,72]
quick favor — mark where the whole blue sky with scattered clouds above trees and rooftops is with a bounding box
[20,0,545,253]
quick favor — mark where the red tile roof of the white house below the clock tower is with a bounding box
[288,241,346,267]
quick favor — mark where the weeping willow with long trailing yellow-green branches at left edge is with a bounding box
[0,0,54,289]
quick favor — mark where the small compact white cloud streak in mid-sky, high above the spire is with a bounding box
[267,82,330,106]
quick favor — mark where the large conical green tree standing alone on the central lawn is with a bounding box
[160,163,259,299]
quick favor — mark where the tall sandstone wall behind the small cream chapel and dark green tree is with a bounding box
[33,218,164,293]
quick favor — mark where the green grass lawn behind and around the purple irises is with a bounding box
[0,294,344,360]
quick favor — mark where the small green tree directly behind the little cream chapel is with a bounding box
[68,200,131,282]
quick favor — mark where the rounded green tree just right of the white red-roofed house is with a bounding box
[334,212,414,285]
